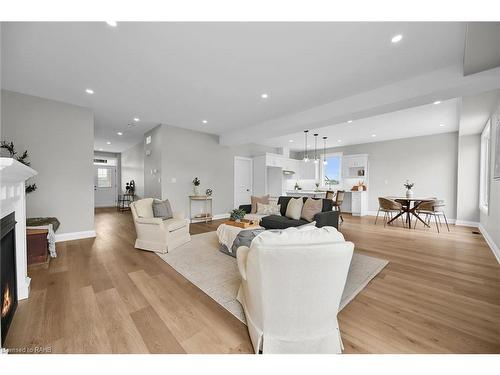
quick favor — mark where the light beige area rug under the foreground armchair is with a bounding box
[158,232,389,324]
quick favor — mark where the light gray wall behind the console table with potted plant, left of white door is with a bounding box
[161,125,276,215]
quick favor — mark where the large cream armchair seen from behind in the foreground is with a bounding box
[237,226,354,353]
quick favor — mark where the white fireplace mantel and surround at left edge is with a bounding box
[0,158,37,299]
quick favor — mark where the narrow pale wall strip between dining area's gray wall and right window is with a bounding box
[457,134,481,224]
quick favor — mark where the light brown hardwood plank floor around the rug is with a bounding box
[5,209,500,353]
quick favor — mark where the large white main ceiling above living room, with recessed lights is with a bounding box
[2,22,465,152]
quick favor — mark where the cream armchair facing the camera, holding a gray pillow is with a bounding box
[130,198,191,253]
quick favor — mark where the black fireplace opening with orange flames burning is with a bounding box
[0,213,17,346]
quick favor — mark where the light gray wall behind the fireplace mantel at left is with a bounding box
[1,90,94,234]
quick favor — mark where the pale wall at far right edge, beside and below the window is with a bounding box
[480,107,500,262]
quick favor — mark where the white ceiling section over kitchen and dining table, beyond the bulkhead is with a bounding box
[263,99,459,151]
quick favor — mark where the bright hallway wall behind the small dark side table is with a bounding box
[121,141,144,199]
